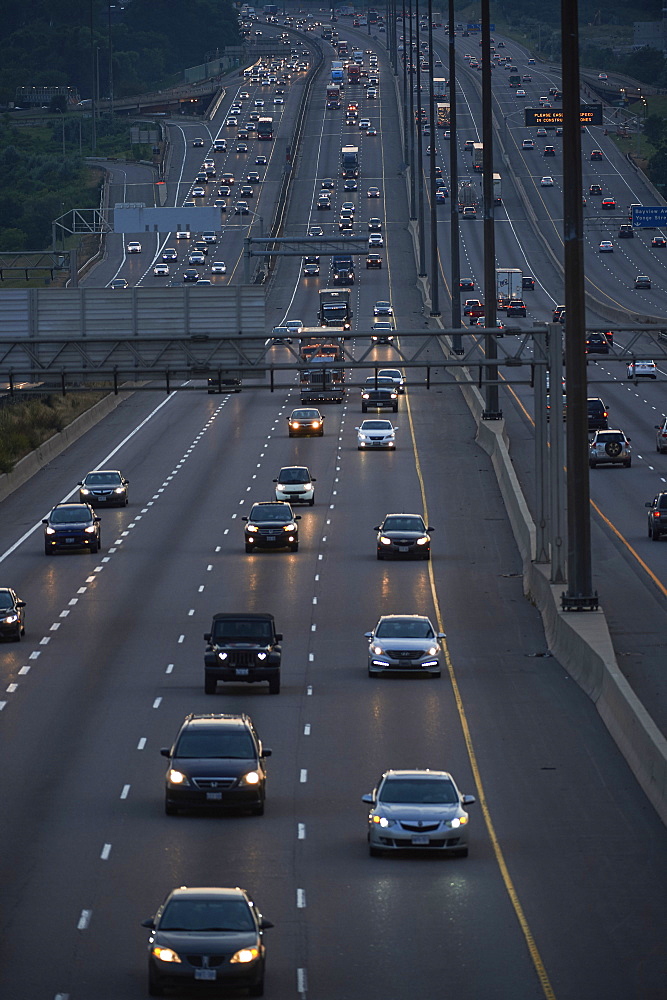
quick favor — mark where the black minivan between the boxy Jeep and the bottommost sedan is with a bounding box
[160,714,271,816]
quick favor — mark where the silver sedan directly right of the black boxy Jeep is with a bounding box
[364,615,445,677]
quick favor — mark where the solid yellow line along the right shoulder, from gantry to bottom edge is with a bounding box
[405,384,556,1000]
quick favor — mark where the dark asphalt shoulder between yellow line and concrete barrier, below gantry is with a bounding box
[402,380,665,997]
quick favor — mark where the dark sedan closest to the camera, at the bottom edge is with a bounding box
[141,886,273,997]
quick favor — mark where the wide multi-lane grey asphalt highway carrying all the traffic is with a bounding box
[0,13,667,1000]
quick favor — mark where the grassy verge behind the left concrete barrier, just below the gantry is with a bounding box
[0,392,105,473]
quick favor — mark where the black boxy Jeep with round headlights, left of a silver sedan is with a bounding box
[204,608,289,694]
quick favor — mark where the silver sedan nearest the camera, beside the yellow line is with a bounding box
[362,769,475,857]
